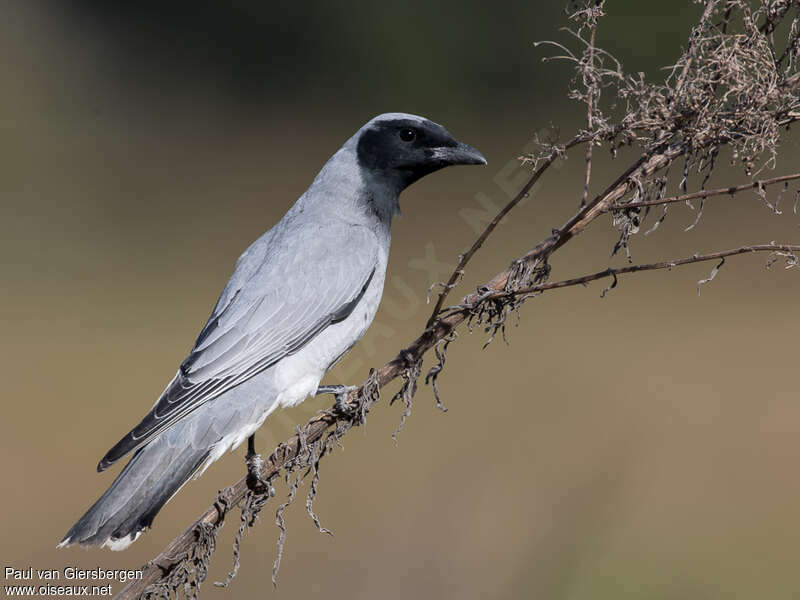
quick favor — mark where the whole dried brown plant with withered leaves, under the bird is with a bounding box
[119,0,800,598]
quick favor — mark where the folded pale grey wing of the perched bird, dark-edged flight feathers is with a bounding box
[97,225,378,471]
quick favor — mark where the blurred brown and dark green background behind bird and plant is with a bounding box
[0,0,800,600]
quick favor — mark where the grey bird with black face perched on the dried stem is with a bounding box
[58,113,486,550]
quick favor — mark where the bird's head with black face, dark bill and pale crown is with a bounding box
[355,113,486,190]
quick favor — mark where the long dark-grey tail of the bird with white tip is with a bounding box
[58,435,210,550]
